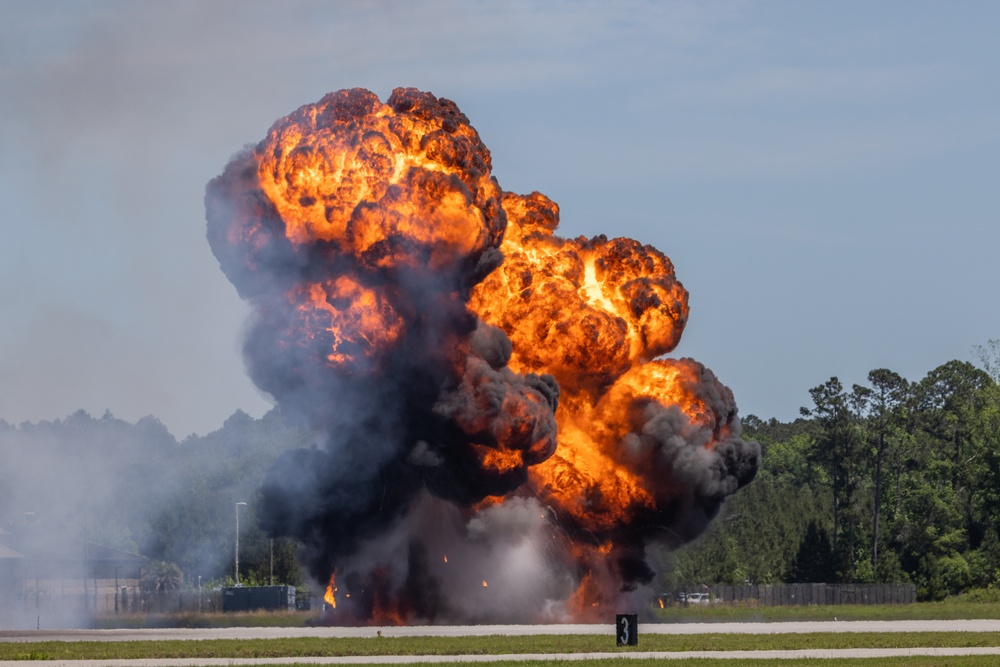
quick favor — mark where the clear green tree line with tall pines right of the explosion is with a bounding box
[659,340,1000,600]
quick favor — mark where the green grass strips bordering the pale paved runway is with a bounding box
[0,599,1000,667]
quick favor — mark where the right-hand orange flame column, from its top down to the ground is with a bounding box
[470,192,752,618]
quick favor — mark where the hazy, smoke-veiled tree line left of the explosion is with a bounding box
[0,410,314,590]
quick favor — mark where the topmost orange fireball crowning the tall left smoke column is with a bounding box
[258,90,503,268]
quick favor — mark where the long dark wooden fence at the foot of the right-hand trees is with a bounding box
[674,584,917,607]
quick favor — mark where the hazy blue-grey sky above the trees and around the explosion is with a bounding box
[0,0,1000,438]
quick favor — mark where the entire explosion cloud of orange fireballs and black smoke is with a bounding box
[206,89,760,623]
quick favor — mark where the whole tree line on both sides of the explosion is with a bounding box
[0,341,1000,600]
